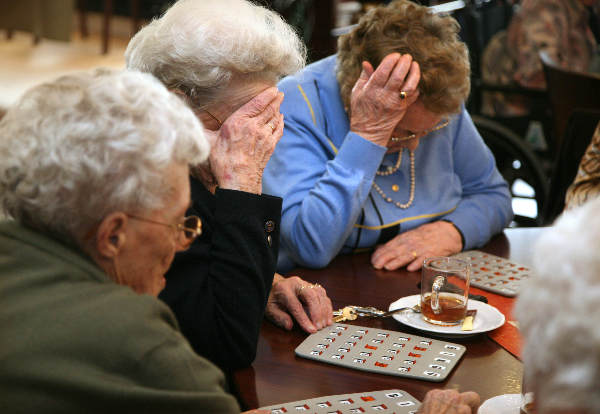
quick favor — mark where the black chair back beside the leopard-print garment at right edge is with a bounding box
[542,109,600,225]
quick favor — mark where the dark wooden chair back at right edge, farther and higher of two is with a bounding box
[540,52,600,157]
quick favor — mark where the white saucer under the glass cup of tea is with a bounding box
[390,295,504,337]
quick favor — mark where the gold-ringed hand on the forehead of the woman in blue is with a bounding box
[350,53,421,147]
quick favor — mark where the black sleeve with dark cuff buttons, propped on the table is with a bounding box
[160,182,281,371]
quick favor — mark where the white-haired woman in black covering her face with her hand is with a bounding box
[125,0,332,370]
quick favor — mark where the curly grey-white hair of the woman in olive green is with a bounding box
[0,69,210,244]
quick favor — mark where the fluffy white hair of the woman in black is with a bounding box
[125,0,306,106]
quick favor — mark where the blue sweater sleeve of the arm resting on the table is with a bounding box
[444,110,513,250]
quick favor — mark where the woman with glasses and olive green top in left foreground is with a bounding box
[0,71,248,413]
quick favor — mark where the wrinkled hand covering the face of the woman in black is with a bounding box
[203,87,283,194]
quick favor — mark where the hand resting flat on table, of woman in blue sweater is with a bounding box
[371,221,463,272]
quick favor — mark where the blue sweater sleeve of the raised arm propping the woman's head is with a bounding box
[263,88,386,270]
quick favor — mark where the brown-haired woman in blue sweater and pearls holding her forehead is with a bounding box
[263,0,512,271]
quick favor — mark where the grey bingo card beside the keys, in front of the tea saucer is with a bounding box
[296,323,466,382]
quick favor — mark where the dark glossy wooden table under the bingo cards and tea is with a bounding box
[233,229,539,409]
